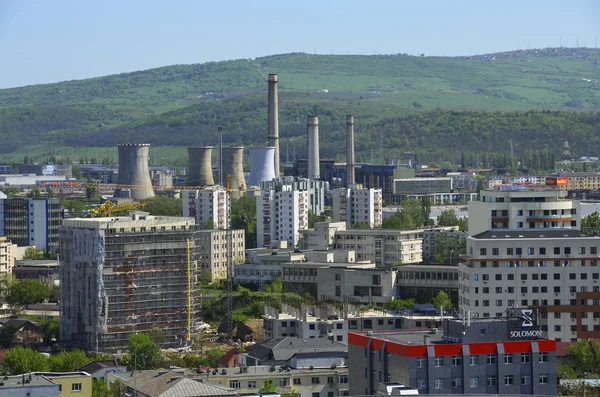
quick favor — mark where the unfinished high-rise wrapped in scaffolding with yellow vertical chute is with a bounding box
[59,211,202,353]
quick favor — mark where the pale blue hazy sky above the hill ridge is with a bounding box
[0,0,600,88]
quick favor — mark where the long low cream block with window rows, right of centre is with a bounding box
[334,229,424,267]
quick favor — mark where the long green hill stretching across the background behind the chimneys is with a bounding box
[0,48,600,160]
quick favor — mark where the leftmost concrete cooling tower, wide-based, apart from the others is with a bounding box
[114,143,154,200]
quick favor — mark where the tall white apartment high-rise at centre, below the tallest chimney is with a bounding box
[256,176,325,248]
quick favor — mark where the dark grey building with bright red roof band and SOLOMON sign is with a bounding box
[348,318,557,395]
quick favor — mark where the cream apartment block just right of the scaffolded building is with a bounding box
[194,229,246,282]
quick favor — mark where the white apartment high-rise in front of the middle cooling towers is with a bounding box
[181,186,231,229]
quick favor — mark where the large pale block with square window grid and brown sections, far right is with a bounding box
[458,229,600,342]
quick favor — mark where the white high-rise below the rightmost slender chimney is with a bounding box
[332,185,383,228]
